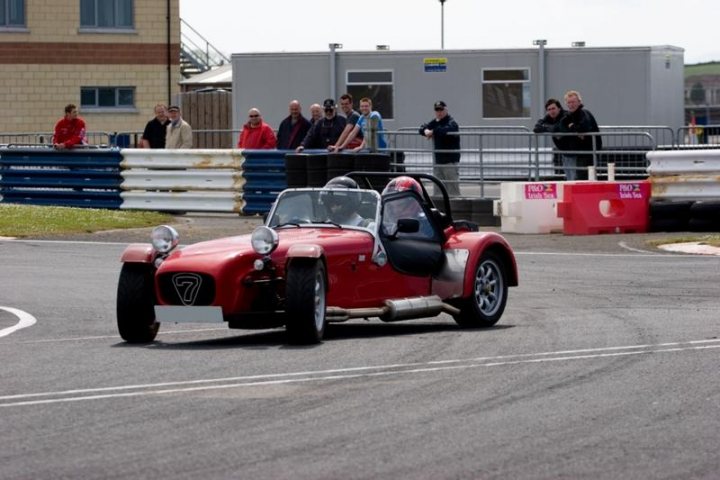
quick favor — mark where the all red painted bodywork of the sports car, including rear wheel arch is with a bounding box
[122,227,518,315]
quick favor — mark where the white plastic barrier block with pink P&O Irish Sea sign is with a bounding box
[493,182,567,233]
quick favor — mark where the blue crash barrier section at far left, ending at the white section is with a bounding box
[0,146,122,209]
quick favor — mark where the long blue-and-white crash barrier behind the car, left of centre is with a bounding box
[0,147,387,215]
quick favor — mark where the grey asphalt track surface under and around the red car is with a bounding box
[0,216,720,479]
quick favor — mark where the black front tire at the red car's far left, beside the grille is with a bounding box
[117,263,160,343]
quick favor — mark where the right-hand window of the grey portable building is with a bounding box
[482,68,530,118]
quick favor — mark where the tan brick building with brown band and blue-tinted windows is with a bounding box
[0,0,182,139]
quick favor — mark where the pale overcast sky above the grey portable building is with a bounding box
[180,0,720,64]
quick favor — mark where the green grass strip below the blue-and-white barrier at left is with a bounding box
[0,204,173,237]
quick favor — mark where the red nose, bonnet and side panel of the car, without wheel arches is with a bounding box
[151,228,430,315]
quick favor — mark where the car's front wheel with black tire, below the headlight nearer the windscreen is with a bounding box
[285,260,327,344]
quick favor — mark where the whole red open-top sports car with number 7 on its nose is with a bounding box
[117,172,518,344]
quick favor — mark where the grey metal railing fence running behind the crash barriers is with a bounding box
[0,125,720,202]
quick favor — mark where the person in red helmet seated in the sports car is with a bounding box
[382,175,435,238]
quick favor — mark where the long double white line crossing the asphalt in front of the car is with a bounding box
[0,339,720,407]
